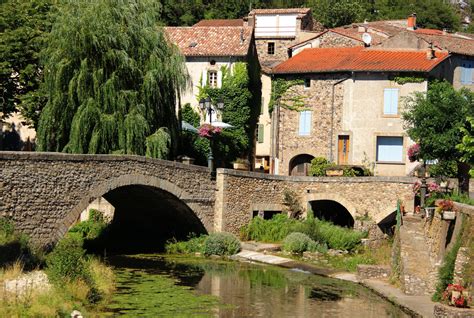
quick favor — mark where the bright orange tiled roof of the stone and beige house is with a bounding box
[272,47,449,74]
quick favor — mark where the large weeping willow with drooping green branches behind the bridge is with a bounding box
[38,0,187,158]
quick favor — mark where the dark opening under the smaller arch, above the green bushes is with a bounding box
[310,200,354,228]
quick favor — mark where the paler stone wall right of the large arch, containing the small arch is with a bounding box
[215,169,414,234]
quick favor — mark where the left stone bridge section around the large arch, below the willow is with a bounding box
[0,152,215,245]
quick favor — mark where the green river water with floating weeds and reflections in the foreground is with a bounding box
[103,255,410,318]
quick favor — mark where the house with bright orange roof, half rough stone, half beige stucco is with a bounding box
[271,46,450,176]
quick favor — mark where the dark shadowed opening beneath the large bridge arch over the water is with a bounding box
[86,185,207,253]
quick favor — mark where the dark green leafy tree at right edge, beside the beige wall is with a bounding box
[402,81,474,189]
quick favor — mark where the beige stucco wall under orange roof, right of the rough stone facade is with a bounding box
[338,74,427,176]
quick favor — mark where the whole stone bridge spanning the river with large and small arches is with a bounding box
[0,152,415,245]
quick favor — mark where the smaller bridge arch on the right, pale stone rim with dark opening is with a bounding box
[306,193,357,227]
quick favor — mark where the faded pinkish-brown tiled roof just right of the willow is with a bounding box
[164,27,252,56]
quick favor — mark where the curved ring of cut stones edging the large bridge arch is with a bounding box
[54,174,212,241]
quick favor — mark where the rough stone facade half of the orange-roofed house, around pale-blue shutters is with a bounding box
[277,75,344,175]
